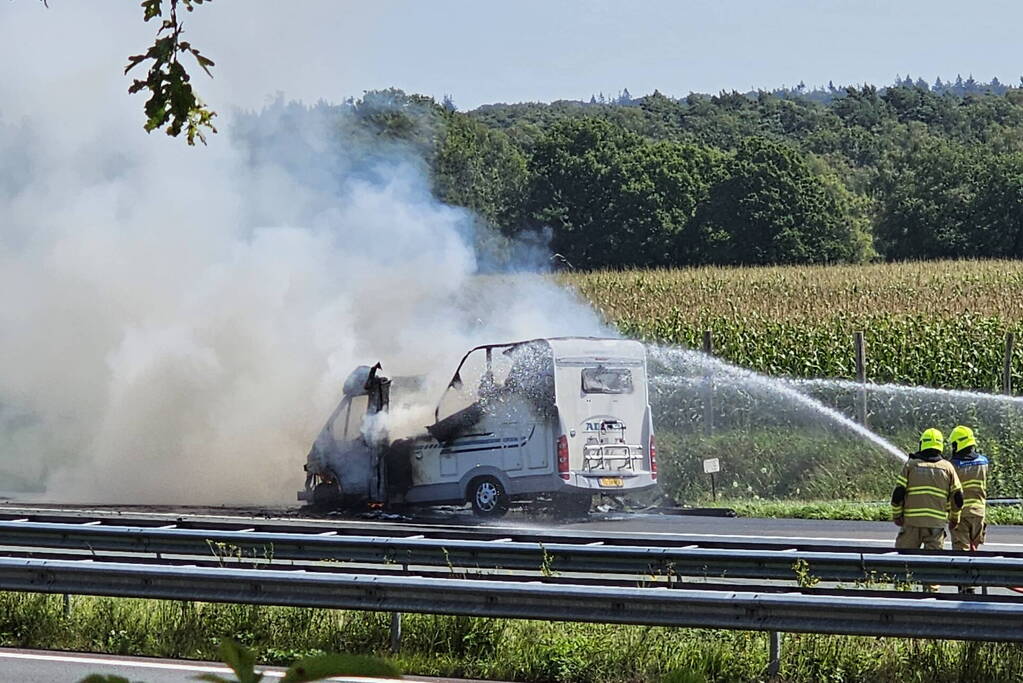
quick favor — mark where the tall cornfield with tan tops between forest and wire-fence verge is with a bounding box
[558,261,1023,392]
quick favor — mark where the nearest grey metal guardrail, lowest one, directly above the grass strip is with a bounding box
[6,558,1023,642]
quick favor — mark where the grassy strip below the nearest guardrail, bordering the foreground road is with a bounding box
[6,593,1023,683]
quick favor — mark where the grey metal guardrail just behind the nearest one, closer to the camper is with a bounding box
[0,521,1023,587]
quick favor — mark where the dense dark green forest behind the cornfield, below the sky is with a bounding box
[239,77,1023,268]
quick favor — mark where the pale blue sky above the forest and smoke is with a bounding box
[6,0,1023,114]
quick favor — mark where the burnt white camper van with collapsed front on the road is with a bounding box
[299,337,657,516]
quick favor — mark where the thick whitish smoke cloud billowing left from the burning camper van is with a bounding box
[0,1,601,503]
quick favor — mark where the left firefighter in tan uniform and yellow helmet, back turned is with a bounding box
[892,428,963,564]
